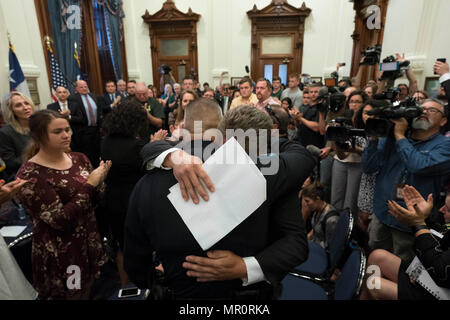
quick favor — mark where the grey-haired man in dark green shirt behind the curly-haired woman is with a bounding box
[135,82,166,136]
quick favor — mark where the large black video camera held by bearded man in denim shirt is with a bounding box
[366,98,423,138]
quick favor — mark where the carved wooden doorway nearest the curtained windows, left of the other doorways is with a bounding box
[142,0,200,93]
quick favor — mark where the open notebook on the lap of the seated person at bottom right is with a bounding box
[406,257,450,300]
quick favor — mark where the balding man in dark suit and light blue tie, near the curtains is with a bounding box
[69,80,103,168]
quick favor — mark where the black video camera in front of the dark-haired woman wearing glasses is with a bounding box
[326,110,366,150]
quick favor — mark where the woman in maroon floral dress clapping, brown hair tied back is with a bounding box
[17,110,111,299]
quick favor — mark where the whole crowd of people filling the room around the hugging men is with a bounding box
[0,55,450,299]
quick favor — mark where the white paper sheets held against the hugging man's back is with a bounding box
[167,138,266,250]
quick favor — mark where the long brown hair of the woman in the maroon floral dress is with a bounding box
[23,110,69,162]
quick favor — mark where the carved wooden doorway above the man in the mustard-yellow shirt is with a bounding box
[247,0,311,84]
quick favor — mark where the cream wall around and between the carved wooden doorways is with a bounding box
[124,0,354,84]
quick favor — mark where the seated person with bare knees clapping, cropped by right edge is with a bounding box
[361,186,450,300]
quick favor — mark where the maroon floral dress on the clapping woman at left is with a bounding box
[17,153,106,299]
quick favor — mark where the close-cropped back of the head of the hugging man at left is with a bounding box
[184,98,222,133]
